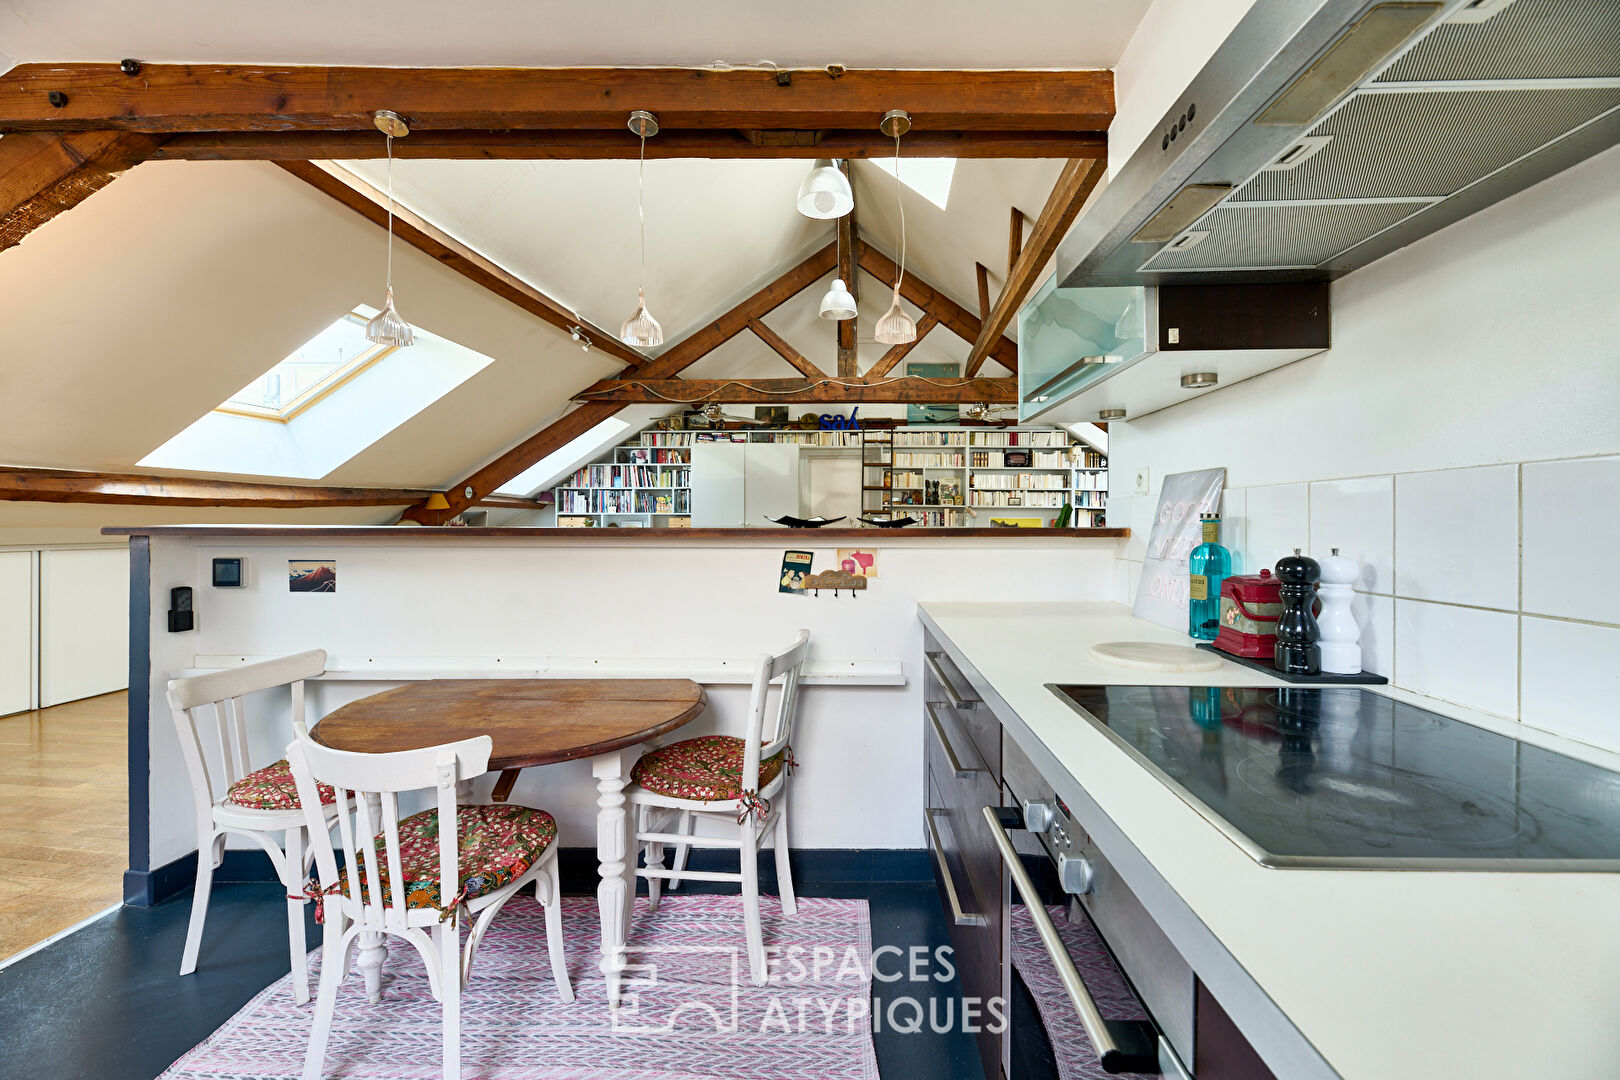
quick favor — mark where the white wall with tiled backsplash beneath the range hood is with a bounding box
[1108,149,1620,748]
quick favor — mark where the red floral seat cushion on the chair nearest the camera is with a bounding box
[327,803,557,912]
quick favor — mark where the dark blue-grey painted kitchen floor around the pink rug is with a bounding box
[0,882,1050,1080]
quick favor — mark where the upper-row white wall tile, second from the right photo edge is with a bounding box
[1395,465,1518,610]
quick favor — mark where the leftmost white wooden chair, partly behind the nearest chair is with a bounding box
[168,649,332,1006]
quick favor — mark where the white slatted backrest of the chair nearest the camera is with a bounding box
[287,732,494,931]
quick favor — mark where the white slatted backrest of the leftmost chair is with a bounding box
[168,649,326,823]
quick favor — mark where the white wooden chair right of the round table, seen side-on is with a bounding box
[625,630,810,986]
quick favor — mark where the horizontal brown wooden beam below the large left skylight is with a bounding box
[0,468,447,510]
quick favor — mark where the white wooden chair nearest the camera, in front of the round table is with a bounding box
[287,732,573,1080]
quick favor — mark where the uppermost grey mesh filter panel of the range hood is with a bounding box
[1374,0,1620,83]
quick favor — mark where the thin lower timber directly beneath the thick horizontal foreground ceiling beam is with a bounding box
[152,130,1108,162]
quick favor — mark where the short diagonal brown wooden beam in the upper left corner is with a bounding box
[0,131,162,251]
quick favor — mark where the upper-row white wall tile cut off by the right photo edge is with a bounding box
[1523,457,1620,623]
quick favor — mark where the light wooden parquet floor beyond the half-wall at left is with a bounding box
[0,691,130,959]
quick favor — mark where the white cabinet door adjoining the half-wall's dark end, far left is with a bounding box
[39,547,127,708]
